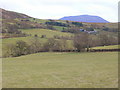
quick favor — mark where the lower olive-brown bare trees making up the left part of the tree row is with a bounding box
[3,37,68,57]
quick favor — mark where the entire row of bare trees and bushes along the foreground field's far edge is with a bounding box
[3,32,118,57]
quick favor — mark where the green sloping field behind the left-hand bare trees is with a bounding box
[2,29,73,45]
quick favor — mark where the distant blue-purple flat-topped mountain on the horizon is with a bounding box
[60,15,109,23]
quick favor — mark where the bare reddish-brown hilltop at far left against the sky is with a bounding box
[0,8,30,19]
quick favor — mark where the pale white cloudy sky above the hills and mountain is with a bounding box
[0,0,119,22]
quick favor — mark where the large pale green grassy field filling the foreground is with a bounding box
[3,52,118,88]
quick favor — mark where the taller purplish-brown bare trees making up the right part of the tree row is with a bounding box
[73,32,118,52]
